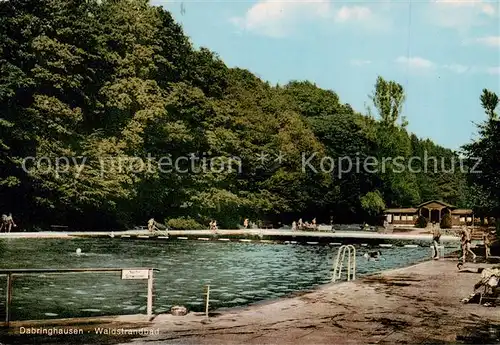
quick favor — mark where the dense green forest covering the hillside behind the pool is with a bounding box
[0,0,498,229]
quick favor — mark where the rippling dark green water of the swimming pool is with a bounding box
[0,238,454,320]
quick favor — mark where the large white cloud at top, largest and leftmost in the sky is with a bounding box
[230,0,386,37]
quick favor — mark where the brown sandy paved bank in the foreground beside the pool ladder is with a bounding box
[127,259,500,345]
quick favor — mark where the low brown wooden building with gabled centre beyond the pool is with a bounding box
[384,200,474,226]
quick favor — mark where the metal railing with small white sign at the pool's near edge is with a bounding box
[0,268,159,326]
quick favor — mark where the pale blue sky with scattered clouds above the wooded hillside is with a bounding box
[152,0,500,150]
